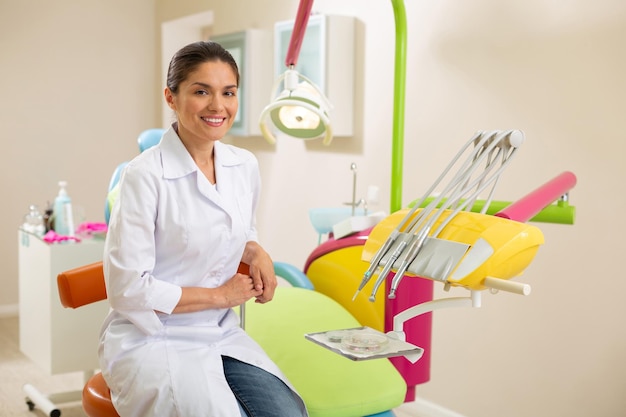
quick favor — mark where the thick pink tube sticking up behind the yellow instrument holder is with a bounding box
[494,171,576,223]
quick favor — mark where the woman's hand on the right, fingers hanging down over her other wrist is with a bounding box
[242,241,278,303]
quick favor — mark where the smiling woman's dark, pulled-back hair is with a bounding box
[167,41,239,94]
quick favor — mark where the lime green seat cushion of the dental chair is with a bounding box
[246,287,406,417]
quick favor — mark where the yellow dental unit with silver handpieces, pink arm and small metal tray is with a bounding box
[307,130,576,363]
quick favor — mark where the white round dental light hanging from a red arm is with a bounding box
[259,0,332,145]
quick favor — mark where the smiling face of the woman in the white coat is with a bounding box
[165,61,239,141]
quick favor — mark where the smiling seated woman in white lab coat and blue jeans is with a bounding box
[99,42,307,417]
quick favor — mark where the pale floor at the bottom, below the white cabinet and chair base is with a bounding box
[0,316,463,417]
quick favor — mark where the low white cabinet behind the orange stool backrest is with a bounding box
[18,230,109,374]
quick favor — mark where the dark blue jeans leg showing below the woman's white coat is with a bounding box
[222,356,305,417]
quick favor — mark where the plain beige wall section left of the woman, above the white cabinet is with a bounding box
[0,0,160,313]
